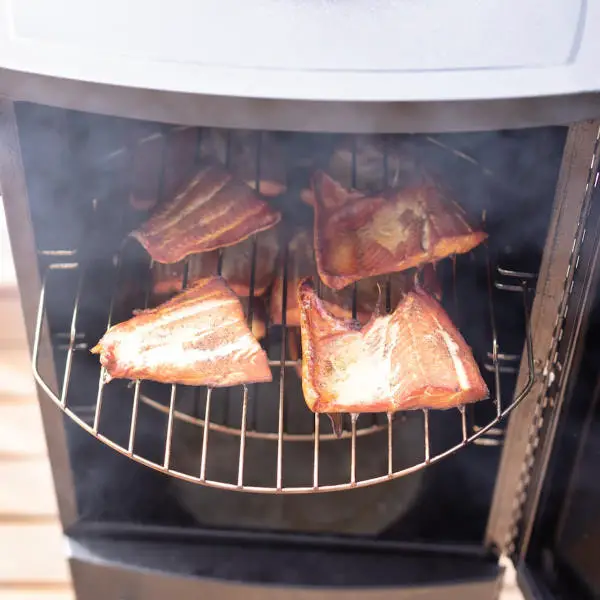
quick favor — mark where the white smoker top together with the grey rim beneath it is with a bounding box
[0,0,600,133]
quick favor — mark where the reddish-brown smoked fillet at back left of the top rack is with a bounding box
[130,162,281,263]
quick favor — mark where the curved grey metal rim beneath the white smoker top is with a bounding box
[0,68,600,133]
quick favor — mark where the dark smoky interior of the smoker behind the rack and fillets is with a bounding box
[12,103,566,545]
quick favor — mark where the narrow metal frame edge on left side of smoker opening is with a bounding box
[0,96,78,529]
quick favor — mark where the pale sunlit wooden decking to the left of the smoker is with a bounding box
[0,198,74,600]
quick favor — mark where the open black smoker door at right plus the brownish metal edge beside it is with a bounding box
[487,121,600,599]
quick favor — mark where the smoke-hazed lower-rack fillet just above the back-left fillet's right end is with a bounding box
[200,128,287,196]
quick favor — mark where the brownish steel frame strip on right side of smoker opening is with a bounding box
[486,121,600,552]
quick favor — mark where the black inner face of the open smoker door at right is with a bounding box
[508,143,600,599]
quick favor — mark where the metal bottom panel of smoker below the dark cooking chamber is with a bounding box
[68,538,503,600]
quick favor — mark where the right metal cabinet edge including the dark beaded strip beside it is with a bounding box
[486,121,600,561]
